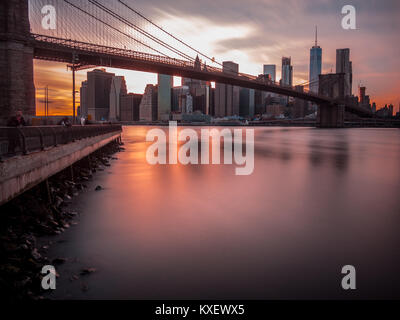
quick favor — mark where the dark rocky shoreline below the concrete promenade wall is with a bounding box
[0,142,124,301]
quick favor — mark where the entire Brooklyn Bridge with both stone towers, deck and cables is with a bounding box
[0,0,372,127]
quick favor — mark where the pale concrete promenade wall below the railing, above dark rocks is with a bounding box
[0,132,121,205]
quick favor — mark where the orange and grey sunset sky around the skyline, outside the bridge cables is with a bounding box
[30,0,400,114]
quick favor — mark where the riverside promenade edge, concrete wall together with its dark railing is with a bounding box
[0,124,122,205]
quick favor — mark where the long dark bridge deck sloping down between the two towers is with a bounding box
[32,34,334,104]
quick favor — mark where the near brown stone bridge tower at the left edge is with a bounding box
[0,0,36,125]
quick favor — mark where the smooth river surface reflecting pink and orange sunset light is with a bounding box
[45,127,400,299]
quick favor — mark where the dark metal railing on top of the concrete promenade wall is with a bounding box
[0,124,122,160]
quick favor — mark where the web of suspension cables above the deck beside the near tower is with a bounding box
[30,0,241,76]
